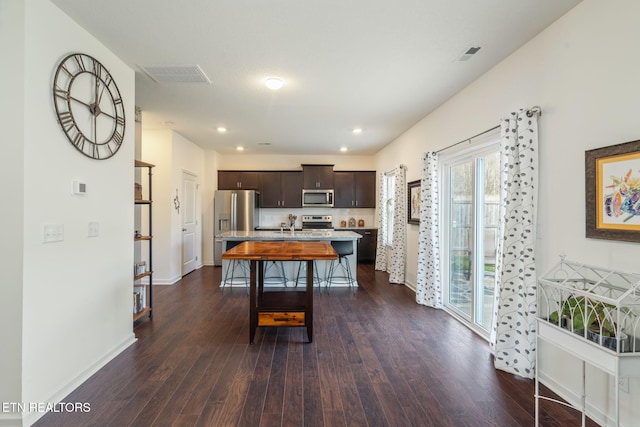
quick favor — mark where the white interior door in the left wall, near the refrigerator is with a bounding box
[180,172,198,276]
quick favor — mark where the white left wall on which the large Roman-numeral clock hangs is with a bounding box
[9,0,135,424]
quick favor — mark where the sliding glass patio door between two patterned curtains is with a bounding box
[441,137,500,336]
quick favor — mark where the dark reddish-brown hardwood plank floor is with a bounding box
[36,265,596,427]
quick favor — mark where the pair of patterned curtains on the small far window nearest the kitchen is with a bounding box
[375,165,407,284]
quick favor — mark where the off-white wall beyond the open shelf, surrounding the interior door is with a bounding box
[140,127,205,284]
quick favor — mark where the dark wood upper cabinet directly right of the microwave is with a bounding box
[333,171,376,208]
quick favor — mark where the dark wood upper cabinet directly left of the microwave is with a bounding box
[260,171,302,208]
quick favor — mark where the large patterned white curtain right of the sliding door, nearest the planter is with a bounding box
[490,110,538,378]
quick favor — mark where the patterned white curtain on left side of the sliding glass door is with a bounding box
[416,152,442,308]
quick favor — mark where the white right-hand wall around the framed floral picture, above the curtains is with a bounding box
[376,0,640,425]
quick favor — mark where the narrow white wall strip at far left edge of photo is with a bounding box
[0,0,25,425]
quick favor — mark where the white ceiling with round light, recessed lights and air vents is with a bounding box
[52,0,580,154]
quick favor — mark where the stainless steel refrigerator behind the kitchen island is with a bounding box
[213,190,260,265]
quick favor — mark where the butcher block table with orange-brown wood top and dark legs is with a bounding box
[222,240,338,343]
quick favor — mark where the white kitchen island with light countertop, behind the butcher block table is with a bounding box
[215,230,362,288]
